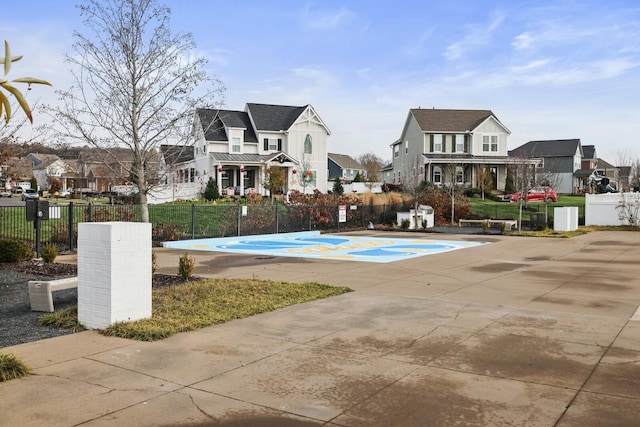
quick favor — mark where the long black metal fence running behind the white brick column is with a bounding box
[0,203,409,250]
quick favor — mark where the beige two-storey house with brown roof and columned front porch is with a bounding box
[391,108,511,190]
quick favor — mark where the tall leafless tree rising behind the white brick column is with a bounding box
[53,0,224,222]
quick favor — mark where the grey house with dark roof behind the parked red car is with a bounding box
[509,138,583,194]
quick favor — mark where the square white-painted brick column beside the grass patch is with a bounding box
[78,222,152,329]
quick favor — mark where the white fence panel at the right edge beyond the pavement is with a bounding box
[584,193,640,226]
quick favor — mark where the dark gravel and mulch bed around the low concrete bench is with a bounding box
[0,261,188,348]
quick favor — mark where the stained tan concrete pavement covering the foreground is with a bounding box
[0,232,640,426]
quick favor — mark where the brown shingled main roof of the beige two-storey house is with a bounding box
[409,108,508,132]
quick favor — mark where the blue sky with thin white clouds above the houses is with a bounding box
[0,0,640,165]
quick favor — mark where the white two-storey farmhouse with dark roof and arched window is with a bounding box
[194,103,331,194]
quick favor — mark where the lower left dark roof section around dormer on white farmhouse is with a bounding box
[197,108,258,142]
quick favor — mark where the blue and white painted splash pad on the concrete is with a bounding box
[164,231,487,263]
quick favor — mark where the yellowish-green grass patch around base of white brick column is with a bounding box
[41,279,351,341]
